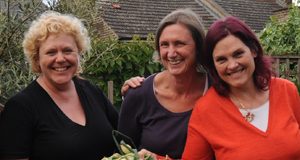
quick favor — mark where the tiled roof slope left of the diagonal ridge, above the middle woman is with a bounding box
[97,0,217,39]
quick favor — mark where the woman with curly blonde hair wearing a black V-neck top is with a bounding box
[0,11,118,160]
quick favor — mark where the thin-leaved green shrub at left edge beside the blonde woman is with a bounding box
[0,0,43,104]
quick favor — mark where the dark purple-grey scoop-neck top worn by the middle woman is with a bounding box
[118,74,192,159]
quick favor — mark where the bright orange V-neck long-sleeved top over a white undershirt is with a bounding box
[182,78,300,160]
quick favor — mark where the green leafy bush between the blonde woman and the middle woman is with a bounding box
[82,35,161,107]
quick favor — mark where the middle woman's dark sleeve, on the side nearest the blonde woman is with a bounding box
[118,89,142,147]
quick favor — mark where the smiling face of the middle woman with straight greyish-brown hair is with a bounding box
[159,24,196,75]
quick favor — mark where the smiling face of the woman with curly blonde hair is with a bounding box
[38,33,79,85]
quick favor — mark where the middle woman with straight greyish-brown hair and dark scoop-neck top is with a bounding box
[118,9,208,159]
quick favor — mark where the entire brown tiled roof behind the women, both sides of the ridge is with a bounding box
[97,0,282,39]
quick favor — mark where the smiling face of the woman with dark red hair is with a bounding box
[213,35,256,88]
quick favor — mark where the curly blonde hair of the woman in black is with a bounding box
[23,11,90,73]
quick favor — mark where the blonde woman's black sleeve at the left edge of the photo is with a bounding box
[0,97,34,159]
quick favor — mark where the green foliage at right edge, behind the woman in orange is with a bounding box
[260,6,300,92]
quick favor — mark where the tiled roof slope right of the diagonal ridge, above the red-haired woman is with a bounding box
[214,0,283,32]
